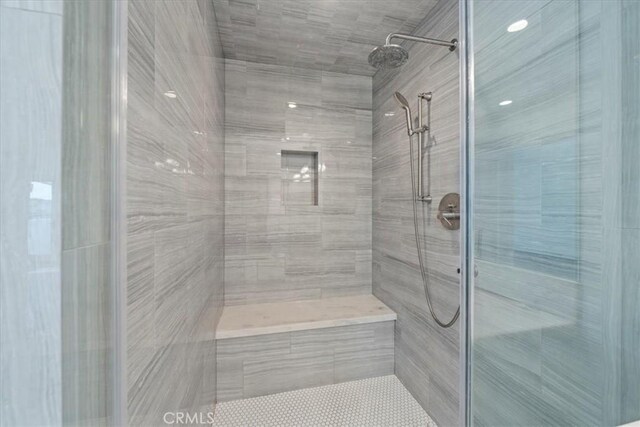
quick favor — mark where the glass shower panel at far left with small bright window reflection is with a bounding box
[0,0,114,426]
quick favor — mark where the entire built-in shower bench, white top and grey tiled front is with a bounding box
[216,295,396,401]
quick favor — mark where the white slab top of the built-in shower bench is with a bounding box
[216,295,396,339]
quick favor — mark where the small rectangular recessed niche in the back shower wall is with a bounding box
[280,150,318,206]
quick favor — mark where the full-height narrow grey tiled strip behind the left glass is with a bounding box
[61,2,115,425]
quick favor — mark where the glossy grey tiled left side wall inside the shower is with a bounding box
[127,0,224,425]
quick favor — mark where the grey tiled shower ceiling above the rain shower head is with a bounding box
[213,0,437,76]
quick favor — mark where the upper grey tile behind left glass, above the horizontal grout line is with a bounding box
[62,2,112,249]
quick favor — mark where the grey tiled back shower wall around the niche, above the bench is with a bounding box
[225,60,372,305]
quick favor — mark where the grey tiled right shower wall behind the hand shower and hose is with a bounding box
[373,0,460,426]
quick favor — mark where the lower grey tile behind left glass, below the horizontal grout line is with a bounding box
[62,242,114,425]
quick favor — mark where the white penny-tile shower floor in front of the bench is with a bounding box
[213,375,436,427]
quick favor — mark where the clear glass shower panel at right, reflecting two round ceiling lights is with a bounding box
[467,0,640,425]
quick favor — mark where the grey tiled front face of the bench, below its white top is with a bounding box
[218,321,394,401]
